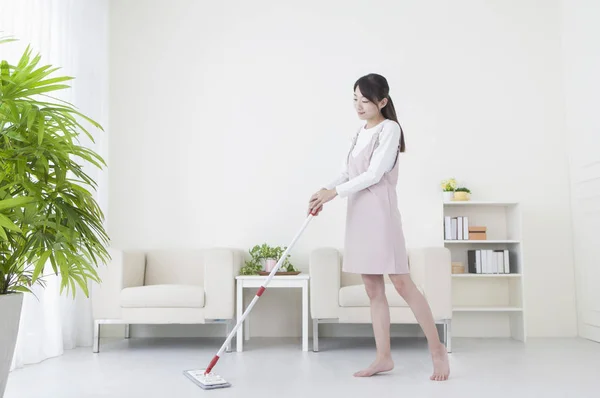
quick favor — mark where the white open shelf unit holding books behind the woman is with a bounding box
[441,201,527,341]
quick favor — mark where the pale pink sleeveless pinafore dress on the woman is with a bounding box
[342,123,409,275]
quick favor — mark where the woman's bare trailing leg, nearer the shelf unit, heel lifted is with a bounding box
[390,274,450,381]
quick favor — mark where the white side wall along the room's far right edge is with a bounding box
[563,0,600,341]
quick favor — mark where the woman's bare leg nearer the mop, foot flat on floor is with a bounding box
[354,275,394,377]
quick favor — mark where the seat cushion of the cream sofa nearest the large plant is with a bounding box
[121,285,204,308]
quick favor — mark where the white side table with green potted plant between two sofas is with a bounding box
[235,273,309,352]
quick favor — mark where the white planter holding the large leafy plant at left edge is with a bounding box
[0,293,23,397]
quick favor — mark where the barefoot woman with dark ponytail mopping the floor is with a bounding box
[309,74,450,381]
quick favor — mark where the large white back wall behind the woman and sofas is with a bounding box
[109,0,576,336]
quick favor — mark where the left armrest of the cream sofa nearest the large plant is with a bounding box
[91,248,146,319]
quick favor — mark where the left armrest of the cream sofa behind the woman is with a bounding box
[309,247,341,319]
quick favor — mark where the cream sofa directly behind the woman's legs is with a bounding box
[309,247,452,351]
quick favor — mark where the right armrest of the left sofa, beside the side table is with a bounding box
[204,248,242,319]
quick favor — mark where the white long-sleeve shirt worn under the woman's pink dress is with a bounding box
[325,119,400,197]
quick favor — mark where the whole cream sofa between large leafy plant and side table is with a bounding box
[91,248,243,352]
